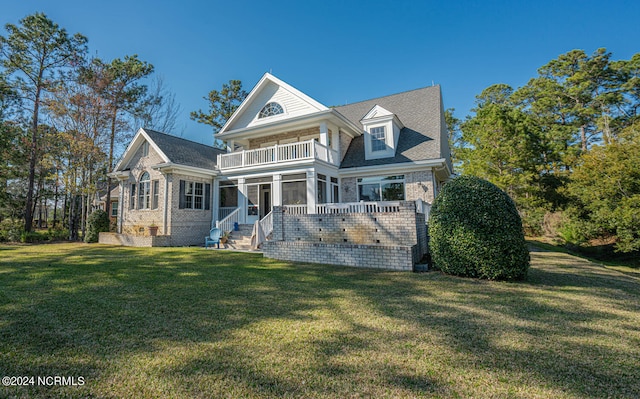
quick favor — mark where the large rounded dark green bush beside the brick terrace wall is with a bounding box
[429,176,529,280]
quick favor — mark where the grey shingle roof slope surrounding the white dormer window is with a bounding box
[335,85,448,168]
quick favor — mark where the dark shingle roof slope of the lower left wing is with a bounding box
[144,129,226,169]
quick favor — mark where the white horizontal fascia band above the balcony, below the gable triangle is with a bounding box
[216,109,363,140]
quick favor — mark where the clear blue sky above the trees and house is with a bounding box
[0,0,640,144]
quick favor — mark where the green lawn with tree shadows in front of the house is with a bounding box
[0,244,640,398]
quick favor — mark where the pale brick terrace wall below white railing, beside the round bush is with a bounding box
[264,201,427,270]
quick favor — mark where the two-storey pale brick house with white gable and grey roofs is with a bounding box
[101,73,452,268]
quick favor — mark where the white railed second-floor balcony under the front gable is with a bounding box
[218,140,340,170]
